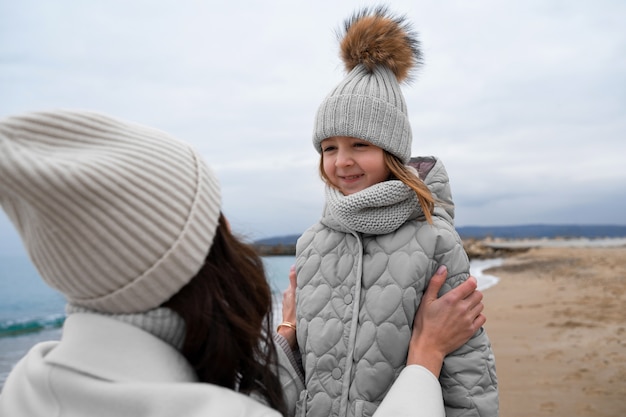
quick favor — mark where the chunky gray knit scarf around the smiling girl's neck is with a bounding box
[324,180,421,235]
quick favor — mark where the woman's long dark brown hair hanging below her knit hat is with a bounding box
[164,215,286,415]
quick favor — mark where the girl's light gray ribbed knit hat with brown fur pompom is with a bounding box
[313,7,421,163]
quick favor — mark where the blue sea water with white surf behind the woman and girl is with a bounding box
[0,255,502,389]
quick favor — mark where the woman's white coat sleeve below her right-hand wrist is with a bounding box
[374,365,445,417]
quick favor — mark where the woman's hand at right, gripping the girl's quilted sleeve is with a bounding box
[407,266,487,377]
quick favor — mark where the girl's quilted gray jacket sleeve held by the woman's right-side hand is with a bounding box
[436,221,499,417]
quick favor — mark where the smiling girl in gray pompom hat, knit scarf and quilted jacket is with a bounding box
[288,8,498,417]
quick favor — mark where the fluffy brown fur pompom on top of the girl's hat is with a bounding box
[339,7,422,82]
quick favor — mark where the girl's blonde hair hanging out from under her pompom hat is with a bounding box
[319,150,437,224]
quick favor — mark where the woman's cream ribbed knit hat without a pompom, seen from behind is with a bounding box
[0,111,220,313]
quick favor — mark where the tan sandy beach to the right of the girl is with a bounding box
[484,245,626,417]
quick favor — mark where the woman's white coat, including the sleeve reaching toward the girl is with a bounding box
[0,313,444,417]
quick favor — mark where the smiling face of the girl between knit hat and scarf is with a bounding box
[321,136,390,195]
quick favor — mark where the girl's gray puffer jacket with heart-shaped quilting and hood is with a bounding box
[296,157,498,417]
